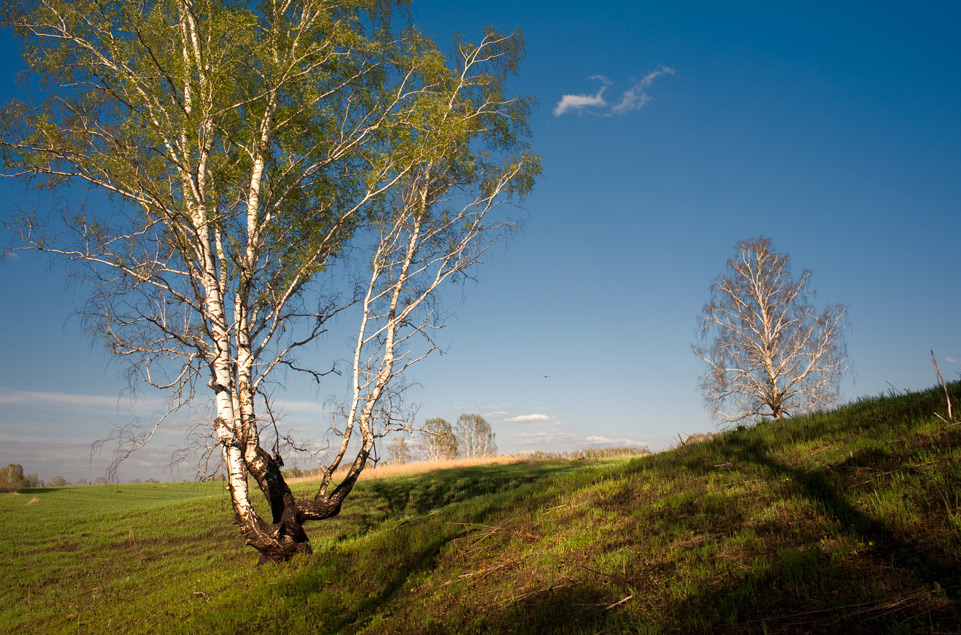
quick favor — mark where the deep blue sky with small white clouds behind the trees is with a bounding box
[0,0,961,480]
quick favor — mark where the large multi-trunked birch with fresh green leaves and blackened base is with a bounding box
[0,0,539,562]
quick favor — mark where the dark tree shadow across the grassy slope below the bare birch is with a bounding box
[652,431,961,634]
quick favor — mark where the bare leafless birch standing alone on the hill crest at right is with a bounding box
[693,238,847,422]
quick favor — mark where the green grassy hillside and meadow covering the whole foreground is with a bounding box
[0,385,961,633]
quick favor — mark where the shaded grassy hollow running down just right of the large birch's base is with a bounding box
[266,466,580,632]
